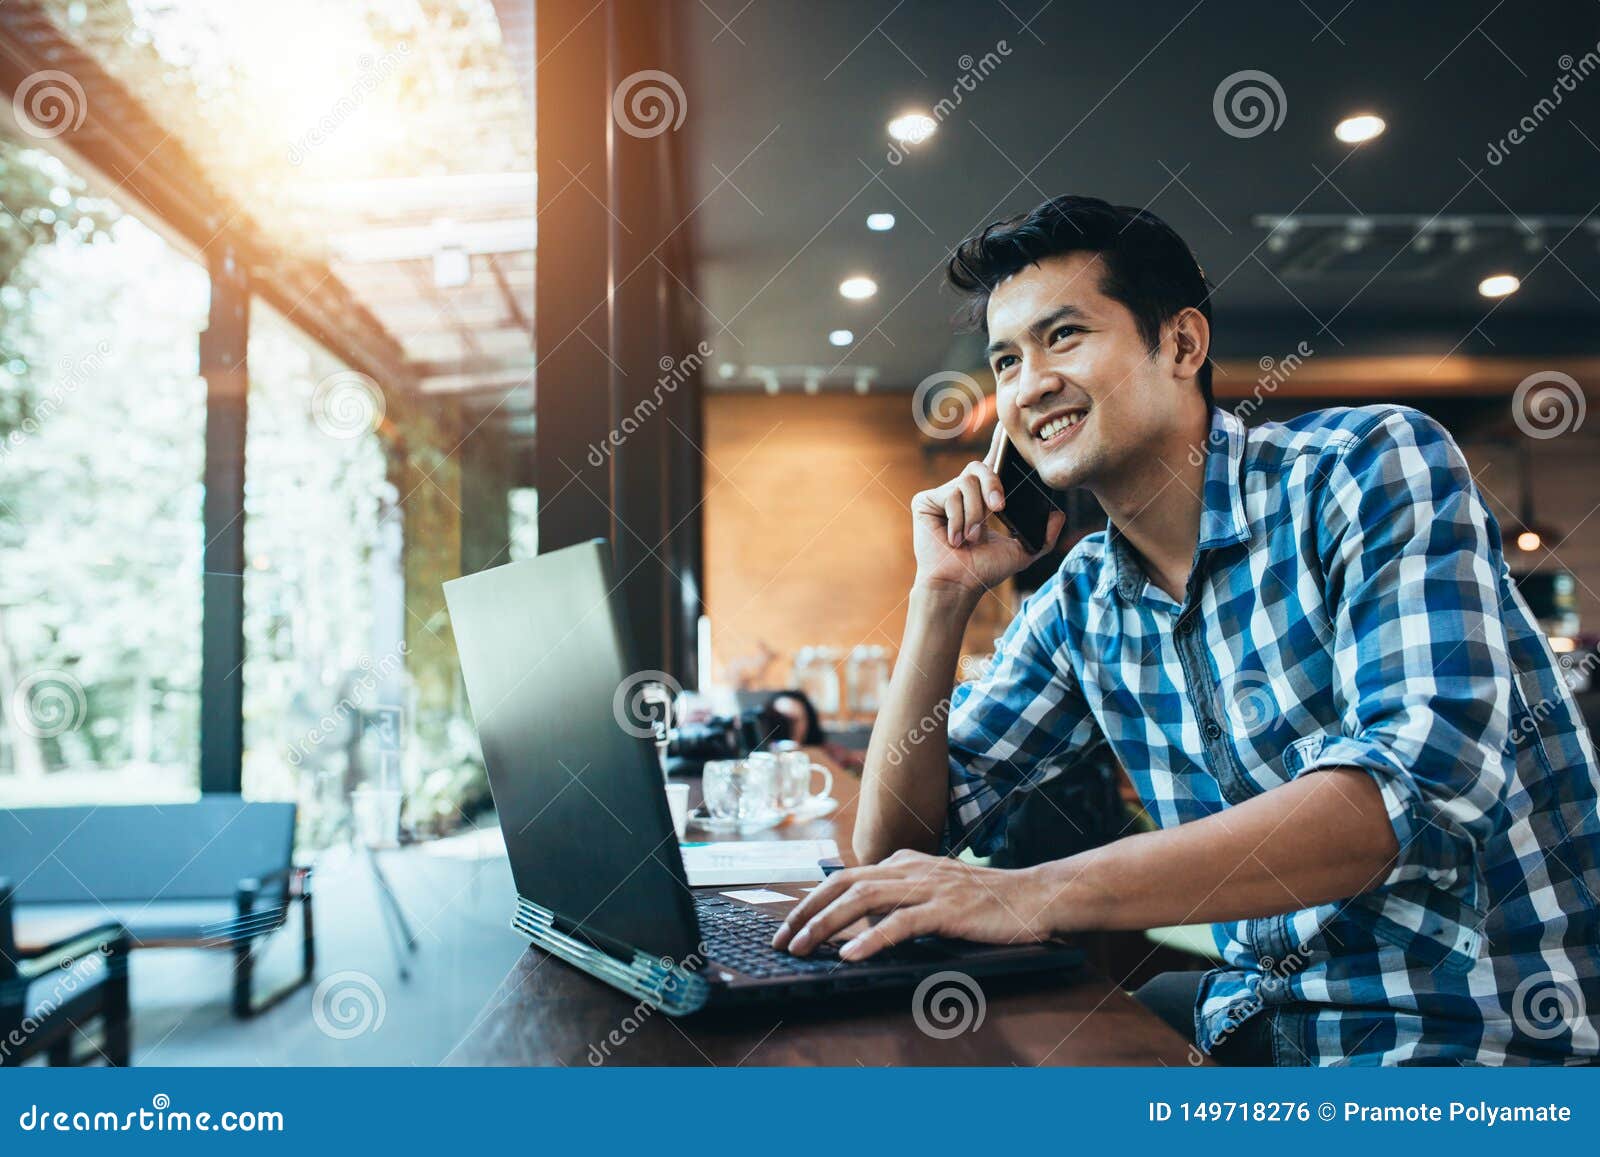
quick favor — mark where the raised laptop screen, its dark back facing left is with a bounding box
[445,539,696,960]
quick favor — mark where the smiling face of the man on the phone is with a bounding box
[989,253,1195,490]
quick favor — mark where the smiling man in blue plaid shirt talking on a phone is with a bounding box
[774,197,1600,1064]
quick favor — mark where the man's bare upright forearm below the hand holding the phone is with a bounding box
[854,587,979,864]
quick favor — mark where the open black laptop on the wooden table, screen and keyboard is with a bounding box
[445,539,1082,1016]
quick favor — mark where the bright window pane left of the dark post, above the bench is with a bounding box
[0,133,210,805]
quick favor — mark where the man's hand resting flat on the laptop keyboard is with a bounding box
[773,851,1059,960]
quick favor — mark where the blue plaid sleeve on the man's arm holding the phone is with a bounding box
[944,578,1101,856]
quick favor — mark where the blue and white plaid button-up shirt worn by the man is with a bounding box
[946,406,1600,1064]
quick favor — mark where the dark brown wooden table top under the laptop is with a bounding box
[448,752,1195,1066]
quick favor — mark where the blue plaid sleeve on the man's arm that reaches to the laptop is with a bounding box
[1301,410,1512,946]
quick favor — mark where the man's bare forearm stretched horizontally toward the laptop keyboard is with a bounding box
[1027,768,1398,933]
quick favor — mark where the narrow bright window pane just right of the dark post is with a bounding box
[243,305,400,847]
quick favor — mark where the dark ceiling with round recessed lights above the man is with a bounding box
[678,0,1600,387]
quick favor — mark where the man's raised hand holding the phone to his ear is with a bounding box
[910,462,1067,597]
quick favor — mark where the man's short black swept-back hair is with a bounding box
[946,195,1213,406]
